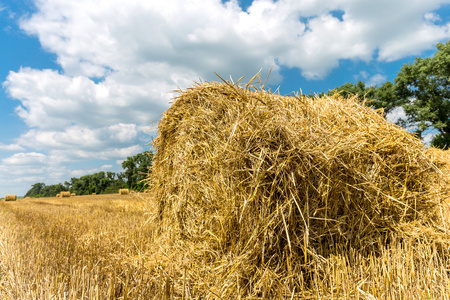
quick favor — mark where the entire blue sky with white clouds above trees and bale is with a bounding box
[0,0,450,198]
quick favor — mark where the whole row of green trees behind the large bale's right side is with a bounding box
[319,41,450,149]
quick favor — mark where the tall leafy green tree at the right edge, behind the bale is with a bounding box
[395,41,450,148]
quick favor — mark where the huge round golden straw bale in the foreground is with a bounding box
[149,83,440,298]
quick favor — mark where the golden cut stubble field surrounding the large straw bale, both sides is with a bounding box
[0,194,450,299]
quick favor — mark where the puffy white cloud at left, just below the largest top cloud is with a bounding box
[4,66,174,130]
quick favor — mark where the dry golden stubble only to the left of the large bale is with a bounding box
[0,195,160,300]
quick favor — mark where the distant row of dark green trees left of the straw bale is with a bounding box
[25,151,153,198]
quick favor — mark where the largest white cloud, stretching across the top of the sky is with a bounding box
[15,0,450,84]
